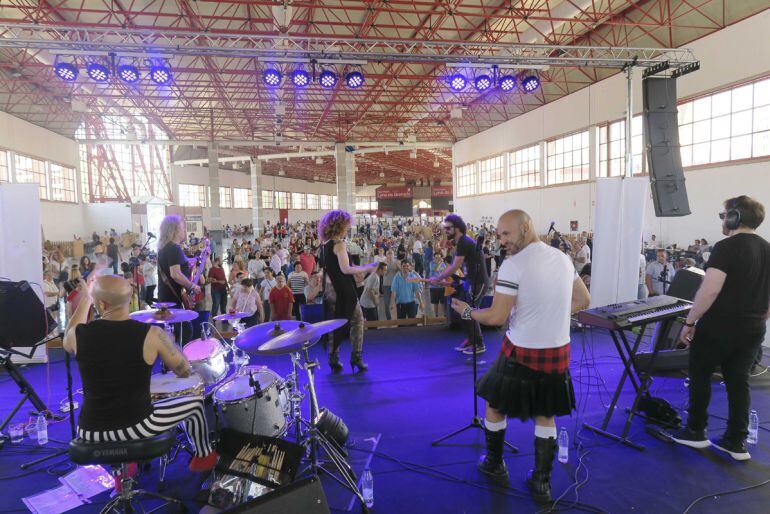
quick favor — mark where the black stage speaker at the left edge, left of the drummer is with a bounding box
[0,280,56,348]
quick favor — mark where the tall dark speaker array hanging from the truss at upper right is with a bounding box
[642,77,690,217]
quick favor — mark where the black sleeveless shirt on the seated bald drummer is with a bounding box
[75,319,152,430]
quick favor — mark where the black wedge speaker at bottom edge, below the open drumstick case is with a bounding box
[225,477,330,514]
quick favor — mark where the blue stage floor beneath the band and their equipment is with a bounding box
[0,327,770,514]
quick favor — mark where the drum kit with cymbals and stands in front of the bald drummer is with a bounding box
[130,304,363,501]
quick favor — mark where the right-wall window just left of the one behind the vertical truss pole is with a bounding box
[546,130,590,185]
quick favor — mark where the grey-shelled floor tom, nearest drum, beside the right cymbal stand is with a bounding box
[214,366,288,437]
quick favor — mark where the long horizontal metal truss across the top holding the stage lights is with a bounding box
[0,23,697,68]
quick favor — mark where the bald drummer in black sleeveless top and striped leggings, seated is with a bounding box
[64,275,217,472]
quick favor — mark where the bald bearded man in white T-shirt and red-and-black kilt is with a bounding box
[452,210,590,503]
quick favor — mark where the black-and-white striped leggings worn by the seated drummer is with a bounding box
[78,396,212,457]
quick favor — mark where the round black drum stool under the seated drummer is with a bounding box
[69,430,186,513]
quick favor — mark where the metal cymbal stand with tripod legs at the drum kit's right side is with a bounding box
[299,346,369,512]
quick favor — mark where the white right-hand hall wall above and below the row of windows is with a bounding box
[453,11,770,245]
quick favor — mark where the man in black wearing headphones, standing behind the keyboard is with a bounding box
[670,196,770,461]
